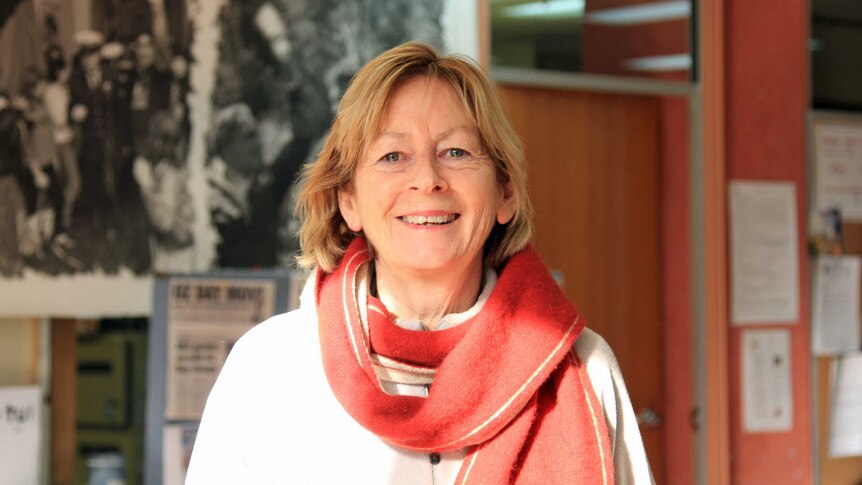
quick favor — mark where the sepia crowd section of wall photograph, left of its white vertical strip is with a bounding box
[0,0,193,278]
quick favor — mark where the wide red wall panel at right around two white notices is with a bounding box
[724,0,813,485]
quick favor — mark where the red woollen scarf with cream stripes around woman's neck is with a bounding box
[316,238,613,485]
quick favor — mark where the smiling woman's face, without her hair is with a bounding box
[339,77,515,273]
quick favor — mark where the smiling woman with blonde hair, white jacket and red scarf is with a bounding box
[187,43,651,484]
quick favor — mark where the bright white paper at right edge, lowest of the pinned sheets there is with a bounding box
[829,352,862,458]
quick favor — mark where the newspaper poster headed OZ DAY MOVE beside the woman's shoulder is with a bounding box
[165,279,275,420]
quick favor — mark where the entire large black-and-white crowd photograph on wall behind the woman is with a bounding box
[0,0,472,314]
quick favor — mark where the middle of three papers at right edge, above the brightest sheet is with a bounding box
[811,256,862,355]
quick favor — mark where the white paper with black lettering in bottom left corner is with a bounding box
[0,386,42,485]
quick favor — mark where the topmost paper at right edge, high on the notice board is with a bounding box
[814,120,862,222]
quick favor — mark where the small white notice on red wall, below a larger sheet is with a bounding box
[742,330,793,433]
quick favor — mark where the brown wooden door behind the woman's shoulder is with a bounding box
[500,85,665,483]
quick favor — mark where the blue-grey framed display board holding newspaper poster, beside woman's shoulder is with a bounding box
[144,270,296,485]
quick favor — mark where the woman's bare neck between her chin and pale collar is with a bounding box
[374,259,482,330]
